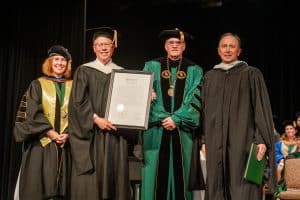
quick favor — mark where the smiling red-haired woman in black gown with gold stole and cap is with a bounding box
[14,45,72,200]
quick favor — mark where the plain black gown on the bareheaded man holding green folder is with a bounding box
[201,62,276,200]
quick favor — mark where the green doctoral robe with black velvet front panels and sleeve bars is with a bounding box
[141,58,203,200]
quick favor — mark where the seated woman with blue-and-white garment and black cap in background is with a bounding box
[275,121,297,182]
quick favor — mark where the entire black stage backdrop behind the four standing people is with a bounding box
[0,0,300,200]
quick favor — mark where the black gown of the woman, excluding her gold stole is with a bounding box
[14,80,71,200]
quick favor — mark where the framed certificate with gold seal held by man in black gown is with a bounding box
[105,69,153,130]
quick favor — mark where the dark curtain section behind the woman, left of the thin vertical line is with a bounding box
[0,0,83,200]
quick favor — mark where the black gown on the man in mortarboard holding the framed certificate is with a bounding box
[69,63,130,200]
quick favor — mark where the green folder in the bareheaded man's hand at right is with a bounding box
[244,143,266,185]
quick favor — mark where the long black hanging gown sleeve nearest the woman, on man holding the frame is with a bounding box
[68,67,94,174]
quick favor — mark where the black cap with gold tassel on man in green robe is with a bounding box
[158,28,194,42]
